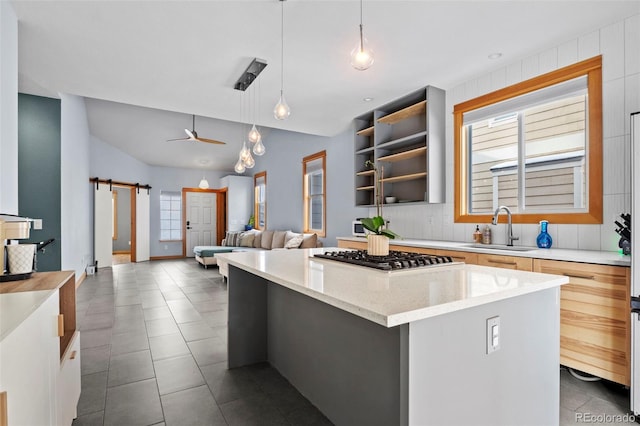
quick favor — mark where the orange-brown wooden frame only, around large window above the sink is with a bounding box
[453,55,603,224]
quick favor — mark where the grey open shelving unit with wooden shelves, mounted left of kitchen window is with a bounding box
[354,86,445,207]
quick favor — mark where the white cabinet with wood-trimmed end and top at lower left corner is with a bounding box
[0,271,80,426]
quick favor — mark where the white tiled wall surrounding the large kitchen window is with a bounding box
[376,15,640,251]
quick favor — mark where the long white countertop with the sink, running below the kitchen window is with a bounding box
[338,237,631,266]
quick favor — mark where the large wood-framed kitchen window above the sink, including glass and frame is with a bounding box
[454,57,602,223]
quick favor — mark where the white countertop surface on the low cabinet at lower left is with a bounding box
[0,289,55,342]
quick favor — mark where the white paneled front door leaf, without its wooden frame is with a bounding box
[185,192,217,257]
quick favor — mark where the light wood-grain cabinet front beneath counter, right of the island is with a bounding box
[534,259,631,386]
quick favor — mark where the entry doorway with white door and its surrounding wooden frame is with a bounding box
[182,188,227,257]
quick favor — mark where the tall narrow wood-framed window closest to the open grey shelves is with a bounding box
[302,151,327,237]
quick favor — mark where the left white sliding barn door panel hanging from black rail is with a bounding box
[93,183,113,268]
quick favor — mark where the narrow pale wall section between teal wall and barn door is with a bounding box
[60,94,93,277]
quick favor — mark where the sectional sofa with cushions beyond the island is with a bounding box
[193,229,322,276]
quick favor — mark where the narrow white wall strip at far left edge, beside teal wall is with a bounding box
[0,1,18,214]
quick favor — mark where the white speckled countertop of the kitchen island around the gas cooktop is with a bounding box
[216,247,569,327]
